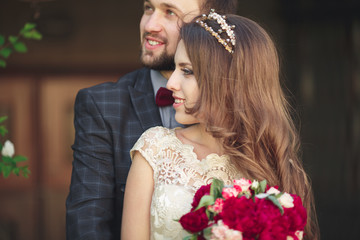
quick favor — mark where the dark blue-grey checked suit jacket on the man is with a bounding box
[66,68,162,240]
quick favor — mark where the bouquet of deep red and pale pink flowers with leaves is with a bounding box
[179,178,307,240]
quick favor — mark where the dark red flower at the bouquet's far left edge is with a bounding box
[179,207,209,233]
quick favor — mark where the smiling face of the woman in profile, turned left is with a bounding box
[166,40,199,125]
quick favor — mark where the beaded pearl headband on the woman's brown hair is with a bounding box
[196,9,236,53]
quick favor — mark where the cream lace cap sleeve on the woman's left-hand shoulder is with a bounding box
[130,127,167,172]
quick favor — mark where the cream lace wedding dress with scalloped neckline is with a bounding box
[131,127,240,240]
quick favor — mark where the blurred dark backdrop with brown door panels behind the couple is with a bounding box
[0,0,360,240]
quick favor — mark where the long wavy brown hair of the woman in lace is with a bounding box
[180,15,319,240]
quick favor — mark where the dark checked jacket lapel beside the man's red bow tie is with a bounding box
[128,69,162,131]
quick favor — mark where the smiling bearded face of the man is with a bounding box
[140,0,200,71]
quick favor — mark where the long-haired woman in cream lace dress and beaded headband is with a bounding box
[121,11,316,240]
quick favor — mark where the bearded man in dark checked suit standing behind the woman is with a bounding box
[66,0,236,240]
